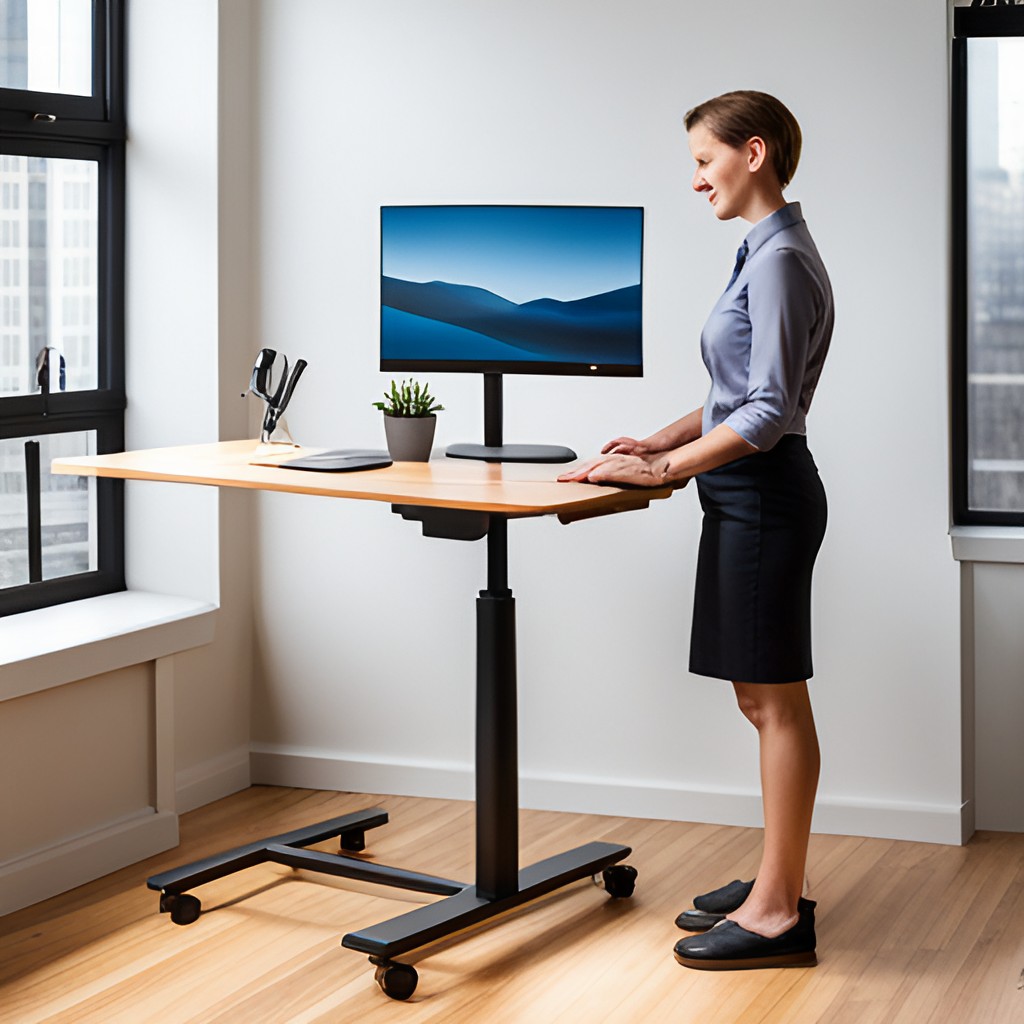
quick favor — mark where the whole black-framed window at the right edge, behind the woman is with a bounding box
[952,2,1024,525]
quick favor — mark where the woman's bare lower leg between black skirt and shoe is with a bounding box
[729,682,821,938]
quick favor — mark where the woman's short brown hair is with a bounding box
[683,89,803,188]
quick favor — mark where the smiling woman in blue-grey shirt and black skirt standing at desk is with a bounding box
[559,91,833,970]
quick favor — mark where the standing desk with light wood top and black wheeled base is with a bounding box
[53,440,672,998]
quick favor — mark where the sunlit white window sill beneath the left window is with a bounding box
[0,591,217,701]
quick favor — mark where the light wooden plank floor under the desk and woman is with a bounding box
[0,787,1024,1024]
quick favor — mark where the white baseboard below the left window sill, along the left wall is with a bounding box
[0,808,178,915]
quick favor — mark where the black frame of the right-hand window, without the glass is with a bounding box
[950,3,1024,526]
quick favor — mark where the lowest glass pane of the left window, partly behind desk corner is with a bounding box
[0,430,97,588]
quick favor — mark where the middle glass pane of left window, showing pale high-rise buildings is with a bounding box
[0,155,99,396]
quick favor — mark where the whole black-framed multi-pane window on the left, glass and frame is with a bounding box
[0,0,126,614]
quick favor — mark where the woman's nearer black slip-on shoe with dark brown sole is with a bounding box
[675,899,818,971]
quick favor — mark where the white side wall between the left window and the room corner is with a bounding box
[125,0,258,810]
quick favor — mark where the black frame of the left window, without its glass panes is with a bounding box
[0,0,127,615]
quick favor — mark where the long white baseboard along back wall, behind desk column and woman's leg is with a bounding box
[251,743,970,846]
